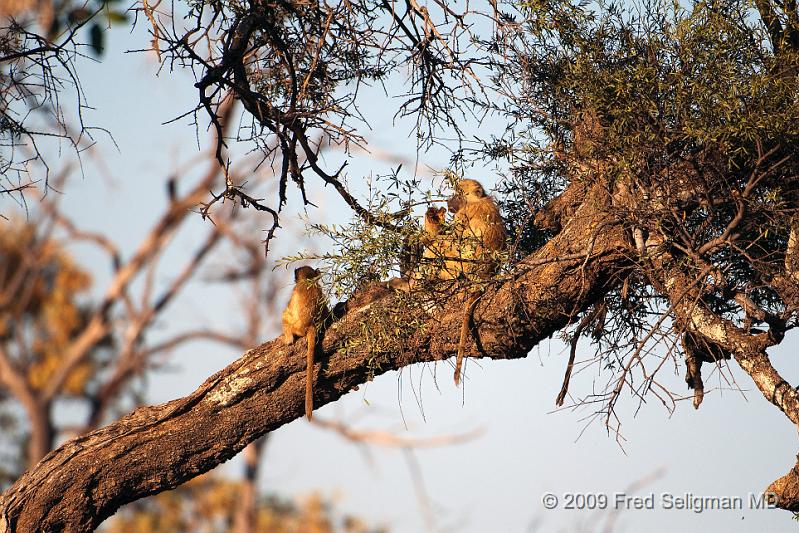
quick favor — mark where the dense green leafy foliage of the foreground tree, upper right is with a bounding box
[484,0,799,332]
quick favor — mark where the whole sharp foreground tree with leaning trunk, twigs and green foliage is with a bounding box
[0,1,799,529]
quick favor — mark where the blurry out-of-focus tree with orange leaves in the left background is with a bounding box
[0,94,306,531]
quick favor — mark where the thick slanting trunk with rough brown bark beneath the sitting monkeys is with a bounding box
[0,184,629,532]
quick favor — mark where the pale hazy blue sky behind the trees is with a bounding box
[32,14,799,532]
